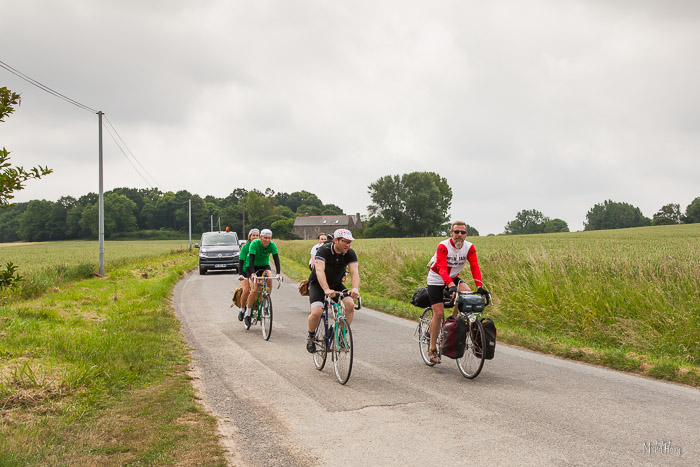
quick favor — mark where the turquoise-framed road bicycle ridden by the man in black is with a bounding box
[313,289,362,384]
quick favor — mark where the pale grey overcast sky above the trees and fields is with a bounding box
[0,0,700,235]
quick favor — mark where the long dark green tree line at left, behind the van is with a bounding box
[0,188,343,242]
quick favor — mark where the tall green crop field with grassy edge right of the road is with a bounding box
[278,224,700,385]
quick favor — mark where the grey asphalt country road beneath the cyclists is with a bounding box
[173,274,700,466]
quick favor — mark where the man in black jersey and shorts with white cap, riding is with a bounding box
[306,229,360,353]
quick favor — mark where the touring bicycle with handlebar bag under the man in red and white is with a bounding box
[414,292,491,379]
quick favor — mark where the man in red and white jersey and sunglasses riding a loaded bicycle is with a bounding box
[428,221,488,363]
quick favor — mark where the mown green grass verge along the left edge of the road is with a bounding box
[0,253,226,465]
